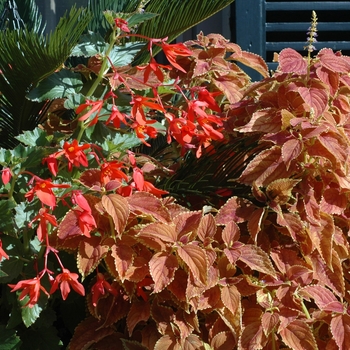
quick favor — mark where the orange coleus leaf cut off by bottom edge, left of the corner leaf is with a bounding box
[280,320,318,350]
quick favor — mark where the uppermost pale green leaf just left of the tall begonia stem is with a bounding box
[71,32,108,57]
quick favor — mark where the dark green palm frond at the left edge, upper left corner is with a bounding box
[0,7,91,147]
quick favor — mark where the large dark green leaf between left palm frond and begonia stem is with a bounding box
[27,69,83,102]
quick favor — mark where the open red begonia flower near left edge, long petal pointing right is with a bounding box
[24,176,70,208]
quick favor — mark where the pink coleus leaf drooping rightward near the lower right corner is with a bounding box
[298,285,344,313]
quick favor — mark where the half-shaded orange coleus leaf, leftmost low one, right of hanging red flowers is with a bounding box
[77,237,109,278]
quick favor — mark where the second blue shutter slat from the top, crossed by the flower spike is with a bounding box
[266,19,350,33]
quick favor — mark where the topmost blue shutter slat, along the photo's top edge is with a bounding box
[265,1,350,11]
